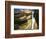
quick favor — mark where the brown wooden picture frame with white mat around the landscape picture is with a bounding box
[5,1,45,38]
